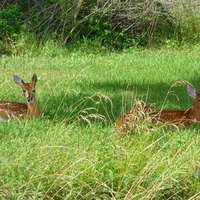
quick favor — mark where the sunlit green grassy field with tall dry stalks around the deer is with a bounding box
[0,48,200,200]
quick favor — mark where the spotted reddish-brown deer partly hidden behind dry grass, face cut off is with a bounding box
[116,82,200,131]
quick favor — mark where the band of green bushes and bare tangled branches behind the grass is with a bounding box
[0,0,200,55]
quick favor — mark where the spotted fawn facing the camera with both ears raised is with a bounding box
[0,73,42,119]
